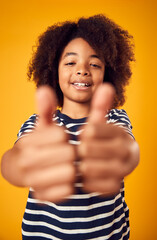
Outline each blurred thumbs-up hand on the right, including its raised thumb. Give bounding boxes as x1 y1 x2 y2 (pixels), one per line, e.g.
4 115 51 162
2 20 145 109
78 84 139 196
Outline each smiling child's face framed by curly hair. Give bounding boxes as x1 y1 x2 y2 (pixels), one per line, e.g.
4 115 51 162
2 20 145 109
58 38 105 107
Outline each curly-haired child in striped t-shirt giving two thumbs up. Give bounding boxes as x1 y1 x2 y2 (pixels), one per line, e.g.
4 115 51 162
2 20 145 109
2 15 139 240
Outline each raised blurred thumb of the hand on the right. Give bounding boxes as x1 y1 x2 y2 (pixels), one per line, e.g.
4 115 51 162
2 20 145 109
89 83 115 123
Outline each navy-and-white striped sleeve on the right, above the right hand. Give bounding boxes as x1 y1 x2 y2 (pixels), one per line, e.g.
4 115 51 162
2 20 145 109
106 109 135 139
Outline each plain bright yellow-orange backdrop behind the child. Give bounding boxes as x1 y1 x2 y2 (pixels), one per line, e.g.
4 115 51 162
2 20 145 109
0 0 157 240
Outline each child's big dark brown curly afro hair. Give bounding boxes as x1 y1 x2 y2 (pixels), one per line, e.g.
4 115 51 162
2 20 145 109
27 15 135 107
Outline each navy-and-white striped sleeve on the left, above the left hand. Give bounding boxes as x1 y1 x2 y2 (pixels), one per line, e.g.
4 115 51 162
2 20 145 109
17 114 38 141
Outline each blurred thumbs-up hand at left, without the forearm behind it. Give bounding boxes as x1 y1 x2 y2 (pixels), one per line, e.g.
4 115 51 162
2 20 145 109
15 87 76 202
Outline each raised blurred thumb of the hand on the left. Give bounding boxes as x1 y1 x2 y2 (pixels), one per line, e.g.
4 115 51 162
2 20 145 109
36 86 57 127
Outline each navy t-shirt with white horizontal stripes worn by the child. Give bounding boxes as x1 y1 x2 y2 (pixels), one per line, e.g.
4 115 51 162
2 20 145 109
18 109 133 240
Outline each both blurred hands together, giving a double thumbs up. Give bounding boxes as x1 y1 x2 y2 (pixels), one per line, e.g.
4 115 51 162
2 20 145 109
2 84 139 202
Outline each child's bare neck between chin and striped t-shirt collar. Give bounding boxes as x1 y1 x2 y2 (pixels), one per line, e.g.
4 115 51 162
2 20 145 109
61 102 90 119
